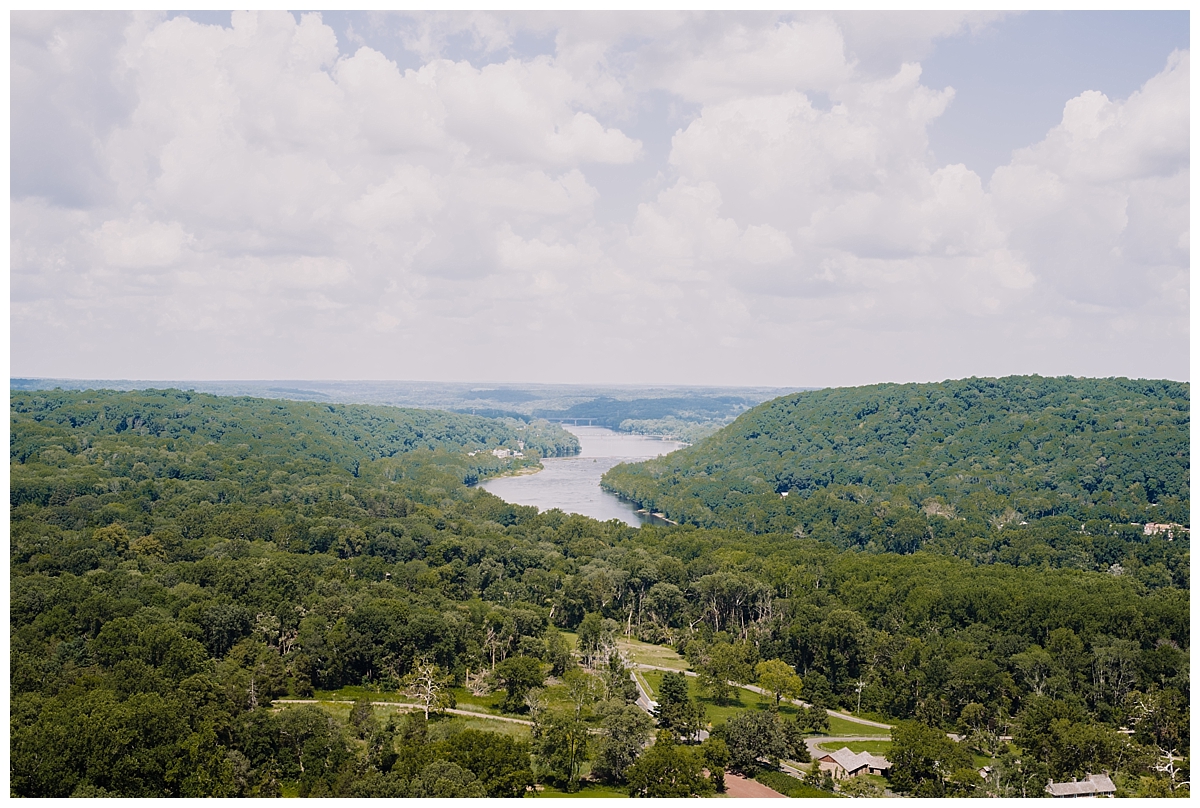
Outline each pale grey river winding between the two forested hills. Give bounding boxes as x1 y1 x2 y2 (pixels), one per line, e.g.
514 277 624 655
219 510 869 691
480 425 684 527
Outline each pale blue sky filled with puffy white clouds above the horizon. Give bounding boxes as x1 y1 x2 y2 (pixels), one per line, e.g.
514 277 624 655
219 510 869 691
10 12 1190 387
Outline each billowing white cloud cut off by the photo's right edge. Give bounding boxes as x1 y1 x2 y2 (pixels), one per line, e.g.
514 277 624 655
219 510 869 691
990 53 1189 312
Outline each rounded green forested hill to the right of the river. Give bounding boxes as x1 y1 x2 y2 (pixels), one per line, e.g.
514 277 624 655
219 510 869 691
605 376 1190 580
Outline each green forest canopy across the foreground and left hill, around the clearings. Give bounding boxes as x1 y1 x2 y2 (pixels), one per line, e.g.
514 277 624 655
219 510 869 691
10 391 1190 797
